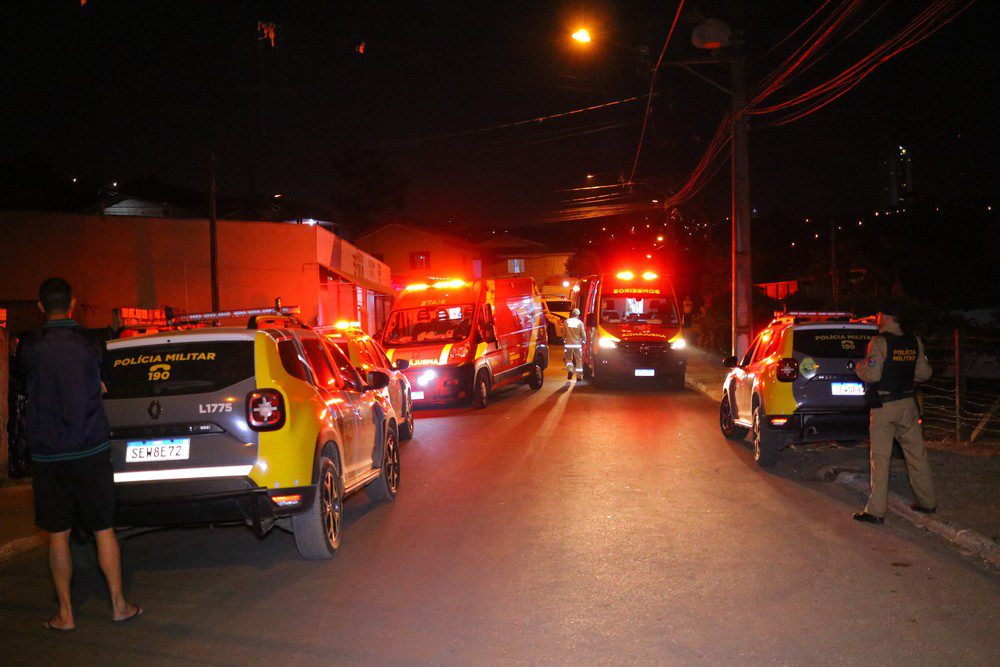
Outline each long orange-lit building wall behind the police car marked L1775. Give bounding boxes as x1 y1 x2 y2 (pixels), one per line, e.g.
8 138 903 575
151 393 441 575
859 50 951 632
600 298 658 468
0 211 370 330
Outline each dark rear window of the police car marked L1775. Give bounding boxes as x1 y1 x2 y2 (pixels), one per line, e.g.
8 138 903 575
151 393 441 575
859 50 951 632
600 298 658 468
106 340 254 398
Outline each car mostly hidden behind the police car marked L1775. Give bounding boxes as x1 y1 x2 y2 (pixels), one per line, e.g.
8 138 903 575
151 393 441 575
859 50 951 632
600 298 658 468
317 321 414 440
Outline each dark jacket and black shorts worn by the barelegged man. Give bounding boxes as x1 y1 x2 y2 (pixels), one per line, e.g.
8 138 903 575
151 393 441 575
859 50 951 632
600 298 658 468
16 319 114 533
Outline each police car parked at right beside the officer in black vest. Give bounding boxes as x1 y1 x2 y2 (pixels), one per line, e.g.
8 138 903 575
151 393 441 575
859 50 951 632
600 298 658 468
719 312 878 467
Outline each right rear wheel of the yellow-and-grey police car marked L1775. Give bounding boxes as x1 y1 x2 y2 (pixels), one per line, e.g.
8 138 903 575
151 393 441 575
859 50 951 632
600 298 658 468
292 456 344 560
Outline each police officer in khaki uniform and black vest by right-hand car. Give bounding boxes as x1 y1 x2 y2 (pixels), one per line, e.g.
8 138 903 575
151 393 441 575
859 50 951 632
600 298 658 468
854 304 937 524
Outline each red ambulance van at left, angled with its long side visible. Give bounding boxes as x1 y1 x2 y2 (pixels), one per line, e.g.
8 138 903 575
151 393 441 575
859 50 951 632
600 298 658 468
380 278 549 408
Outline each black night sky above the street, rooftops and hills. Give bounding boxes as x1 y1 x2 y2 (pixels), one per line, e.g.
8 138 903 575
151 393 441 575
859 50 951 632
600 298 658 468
0 0 1000 229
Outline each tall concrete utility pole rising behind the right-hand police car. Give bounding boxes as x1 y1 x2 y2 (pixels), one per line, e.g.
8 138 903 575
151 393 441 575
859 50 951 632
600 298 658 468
730 42 753 358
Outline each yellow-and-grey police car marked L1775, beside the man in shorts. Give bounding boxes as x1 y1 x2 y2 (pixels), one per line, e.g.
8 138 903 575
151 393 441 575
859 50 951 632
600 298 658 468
105 311 400 559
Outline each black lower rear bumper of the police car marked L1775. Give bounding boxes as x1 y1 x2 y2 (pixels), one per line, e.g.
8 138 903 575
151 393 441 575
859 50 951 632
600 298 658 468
115 477 316 534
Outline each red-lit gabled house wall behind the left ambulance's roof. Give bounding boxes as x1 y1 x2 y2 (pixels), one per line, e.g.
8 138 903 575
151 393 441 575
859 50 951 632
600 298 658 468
356 224 479 287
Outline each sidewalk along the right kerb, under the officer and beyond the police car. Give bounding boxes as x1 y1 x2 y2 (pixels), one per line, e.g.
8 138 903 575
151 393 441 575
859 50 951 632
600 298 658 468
687 348 1000 565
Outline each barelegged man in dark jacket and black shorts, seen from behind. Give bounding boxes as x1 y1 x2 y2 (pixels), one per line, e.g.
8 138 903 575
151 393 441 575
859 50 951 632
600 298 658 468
17 278 142 630
